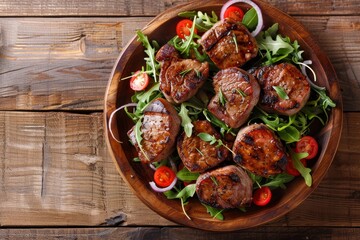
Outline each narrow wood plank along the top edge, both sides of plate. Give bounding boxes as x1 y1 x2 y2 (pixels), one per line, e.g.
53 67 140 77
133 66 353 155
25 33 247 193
0 0 360 17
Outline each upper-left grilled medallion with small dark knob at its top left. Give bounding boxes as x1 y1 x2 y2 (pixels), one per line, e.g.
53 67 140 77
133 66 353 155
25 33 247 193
156 44 209 103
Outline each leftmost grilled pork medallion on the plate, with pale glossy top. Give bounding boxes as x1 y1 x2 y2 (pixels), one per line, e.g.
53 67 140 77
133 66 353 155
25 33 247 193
128 98 181 163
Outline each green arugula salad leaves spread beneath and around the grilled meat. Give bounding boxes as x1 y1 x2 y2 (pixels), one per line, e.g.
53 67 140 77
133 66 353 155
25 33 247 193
119 5 335 220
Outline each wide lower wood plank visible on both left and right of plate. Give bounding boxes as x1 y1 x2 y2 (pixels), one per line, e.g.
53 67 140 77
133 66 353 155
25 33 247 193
0 111 360 227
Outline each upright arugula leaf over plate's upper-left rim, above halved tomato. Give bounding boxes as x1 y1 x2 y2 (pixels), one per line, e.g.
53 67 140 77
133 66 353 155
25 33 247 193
136 30 160 82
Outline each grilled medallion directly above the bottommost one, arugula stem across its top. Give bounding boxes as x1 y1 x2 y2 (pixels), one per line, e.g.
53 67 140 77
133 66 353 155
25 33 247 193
177 121 230 173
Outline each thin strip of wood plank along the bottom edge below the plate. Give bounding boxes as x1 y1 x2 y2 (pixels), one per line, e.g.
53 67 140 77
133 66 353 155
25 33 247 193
0 227 360 240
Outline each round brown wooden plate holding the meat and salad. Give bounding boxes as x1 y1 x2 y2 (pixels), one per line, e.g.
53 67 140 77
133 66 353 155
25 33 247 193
104 0 342 231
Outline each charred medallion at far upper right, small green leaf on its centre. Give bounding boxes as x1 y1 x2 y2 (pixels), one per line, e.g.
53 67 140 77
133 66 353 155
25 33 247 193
252 63 310 116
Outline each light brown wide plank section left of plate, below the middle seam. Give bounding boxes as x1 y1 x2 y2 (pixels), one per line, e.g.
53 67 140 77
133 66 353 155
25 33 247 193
0 112 172 226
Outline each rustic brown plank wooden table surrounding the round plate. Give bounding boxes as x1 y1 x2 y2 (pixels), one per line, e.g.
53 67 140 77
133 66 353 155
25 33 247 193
0 0 360 239
